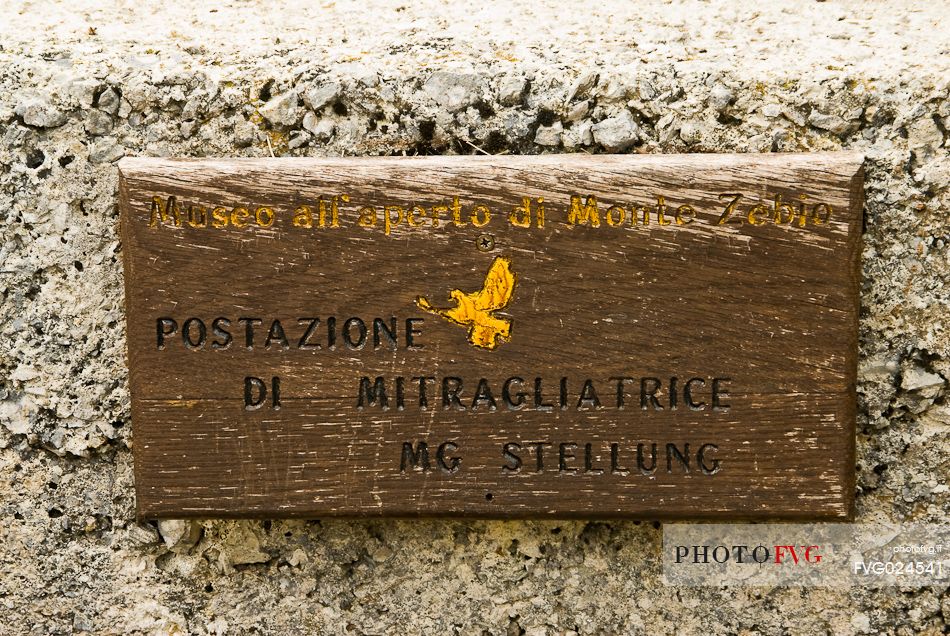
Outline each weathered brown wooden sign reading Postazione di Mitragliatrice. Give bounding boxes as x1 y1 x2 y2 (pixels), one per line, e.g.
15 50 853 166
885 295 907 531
120 154 862 519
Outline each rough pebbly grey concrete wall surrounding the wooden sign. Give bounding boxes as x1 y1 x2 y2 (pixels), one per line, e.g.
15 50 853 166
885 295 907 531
0 0 950 634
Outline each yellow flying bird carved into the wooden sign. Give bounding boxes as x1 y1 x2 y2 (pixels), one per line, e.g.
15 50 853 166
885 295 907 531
416 256 515 350
